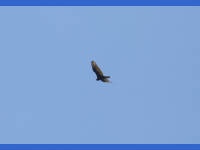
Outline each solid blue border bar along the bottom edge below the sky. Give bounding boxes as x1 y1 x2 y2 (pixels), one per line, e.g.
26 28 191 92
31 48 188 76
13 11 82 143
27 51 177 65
0 144 200 150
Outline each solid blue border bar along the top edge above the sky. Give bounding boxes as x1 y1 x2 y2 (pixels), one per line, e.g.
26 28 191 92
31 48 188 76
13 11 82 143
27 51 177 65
0 0 200 6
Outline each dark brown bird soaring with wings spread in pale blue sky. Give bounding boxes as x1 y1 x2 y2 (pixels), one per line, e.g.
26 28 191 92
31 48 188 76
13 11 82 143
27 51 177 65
91 61 110 82
